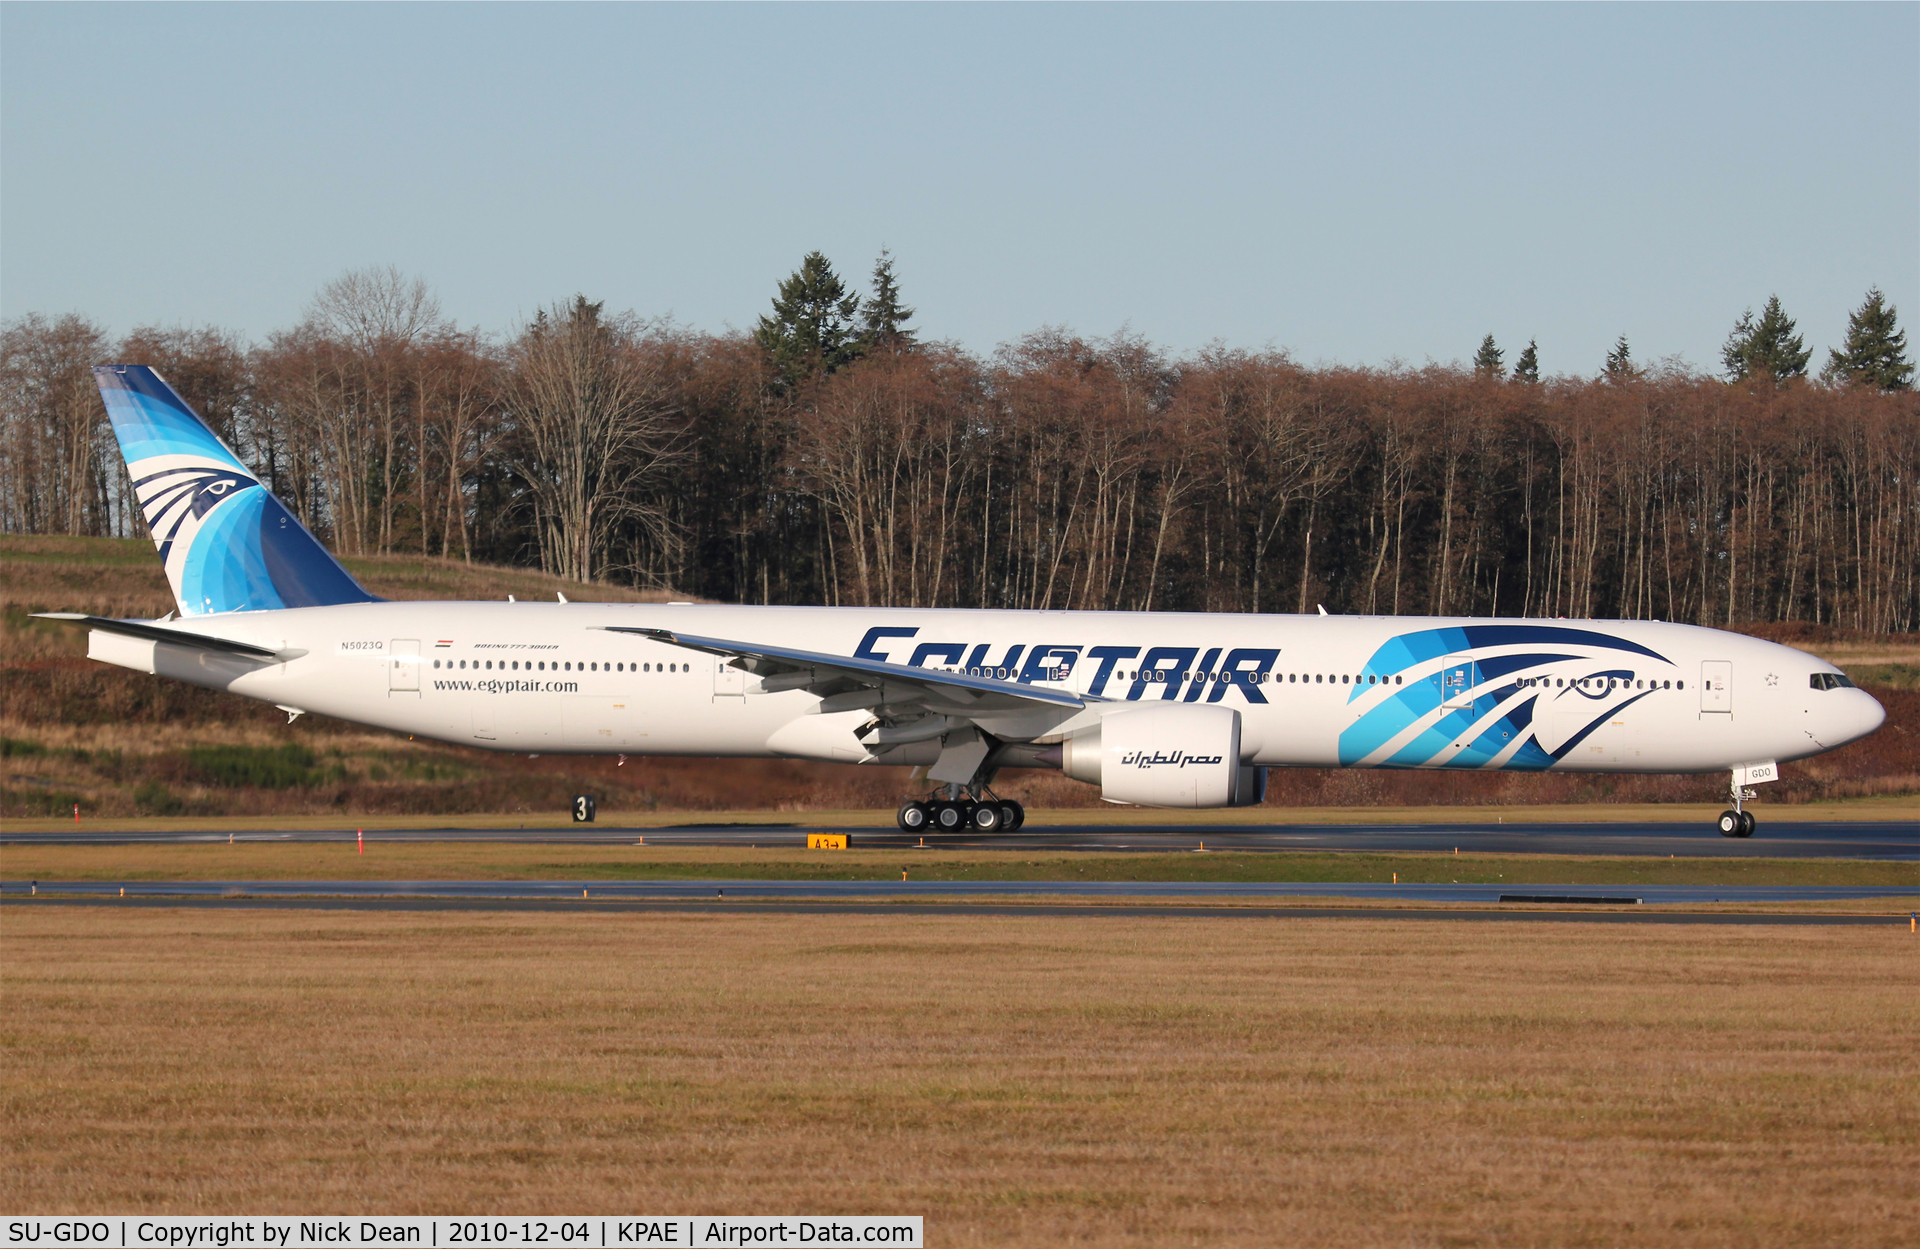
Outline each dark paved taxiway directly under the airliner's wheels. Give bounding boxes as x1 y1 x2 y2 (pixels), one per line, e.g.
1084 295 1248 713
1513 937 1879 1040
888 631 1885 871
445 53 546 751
0 815 1920 861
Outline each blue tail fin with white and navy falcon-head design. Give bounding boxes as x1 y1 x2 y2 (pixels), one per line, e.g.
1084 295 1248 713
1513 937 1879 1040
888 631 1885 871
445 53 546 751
94 365 378 616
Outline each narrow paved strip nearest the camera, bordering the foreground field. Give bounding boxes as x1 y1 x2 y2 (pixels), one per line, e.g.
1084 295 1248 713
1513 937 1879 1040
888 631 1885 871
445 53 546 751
0 879 1920 906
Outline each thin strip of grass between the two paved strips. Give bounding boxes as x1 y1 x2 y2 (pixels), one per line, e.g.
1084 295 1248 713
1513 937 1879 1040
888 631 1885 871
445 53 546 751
0 838 1920 894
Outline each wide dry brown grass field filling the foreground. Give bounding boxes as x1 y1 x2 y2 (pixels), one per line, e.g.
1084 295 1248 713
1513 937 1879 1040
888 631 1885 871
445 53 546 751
0 906 1920 1245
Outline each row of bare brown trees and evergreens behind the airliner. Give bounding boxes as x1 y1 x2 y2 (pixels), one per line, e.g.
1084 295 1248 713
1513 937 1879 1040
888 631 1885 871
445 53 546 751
0 264 1920 631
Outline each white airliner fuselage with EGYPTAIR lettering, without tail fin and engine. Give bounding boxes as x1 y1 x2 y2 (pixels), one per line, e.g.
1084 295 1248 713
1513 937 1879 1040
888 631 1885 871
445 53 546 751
92 602 1884 771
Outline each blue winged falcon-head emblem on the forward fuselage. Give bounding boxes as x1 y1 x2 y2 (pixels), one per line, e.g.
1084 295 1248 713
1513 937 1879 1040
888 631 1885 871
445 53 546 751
1340 624 1668 771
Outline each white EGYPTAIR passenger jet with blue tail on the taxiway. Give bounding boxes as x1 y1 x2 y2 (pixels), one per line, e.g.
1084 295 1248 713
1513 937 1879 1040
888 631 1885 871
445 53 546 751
44 365 1885 837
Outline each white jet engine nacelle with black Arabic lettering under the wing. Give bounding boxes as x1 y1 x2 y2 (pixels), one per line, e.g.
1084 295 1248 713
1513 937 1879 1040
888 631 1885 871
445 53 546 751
1060 702 1267 808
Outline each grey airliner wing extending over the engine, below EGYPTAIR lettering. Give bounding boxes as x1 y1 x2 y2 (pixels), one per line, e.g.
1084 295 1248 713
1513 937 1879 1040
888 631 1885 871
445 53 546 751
605 625 1087 716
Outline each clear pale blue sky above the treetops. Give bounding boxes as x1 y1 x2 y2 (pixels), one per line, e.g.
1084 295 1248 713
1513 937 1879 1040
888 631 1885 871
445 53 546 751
0 2 1920 372
